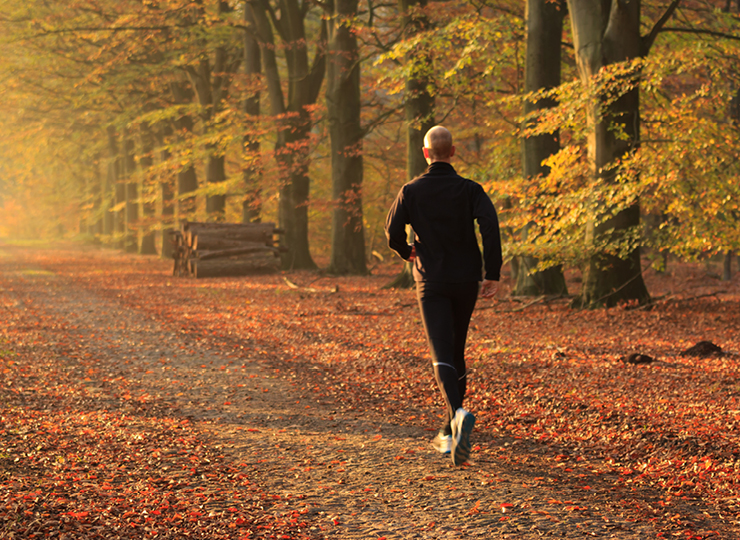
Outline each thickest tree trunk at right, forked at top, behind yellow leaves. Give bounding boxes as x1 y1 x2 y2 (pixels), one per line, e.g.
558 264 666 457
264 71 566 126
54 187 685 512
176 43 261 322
568 0 650 307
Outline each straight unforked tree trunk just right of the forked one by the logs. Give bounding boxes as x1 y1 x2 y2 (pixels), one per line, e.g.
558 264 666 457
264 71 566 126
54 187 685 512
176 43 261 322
326 0 367 274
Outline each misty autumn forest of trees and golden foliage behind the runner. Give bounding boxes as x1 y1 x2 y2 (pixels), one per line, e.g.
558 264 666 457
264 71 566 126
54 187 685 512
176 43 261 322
0 0 740 306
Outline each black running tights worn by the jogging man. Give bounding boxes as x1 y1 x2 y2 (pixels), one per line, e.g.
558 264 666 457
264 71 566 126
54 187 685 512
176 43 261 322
416 281 478 434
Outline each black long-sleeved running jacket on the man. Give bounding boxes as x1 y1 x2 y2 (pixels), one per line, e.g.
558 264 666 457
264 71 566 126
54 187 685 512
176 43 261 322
385 161 502 283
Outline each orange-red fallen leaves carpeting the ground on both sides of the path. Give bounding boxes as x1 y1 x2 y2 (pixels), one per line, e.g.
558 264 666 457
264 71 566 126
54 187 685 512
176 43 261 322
0 247 740 538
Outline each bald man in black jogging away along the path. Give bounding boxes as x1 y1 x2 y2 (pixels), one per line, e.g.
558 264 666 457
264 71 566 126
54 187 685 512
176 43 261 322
385 126 502 465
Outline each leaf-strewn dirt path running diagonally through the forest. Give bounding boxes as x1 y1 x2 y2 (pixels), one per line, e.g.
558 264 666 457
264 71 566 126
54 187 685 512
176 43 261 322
0 249 729 540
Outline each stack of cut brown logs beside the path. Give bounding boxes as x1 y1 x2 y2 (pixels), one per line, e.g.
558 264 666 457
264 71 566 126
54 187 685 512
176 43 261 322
170 221 281 278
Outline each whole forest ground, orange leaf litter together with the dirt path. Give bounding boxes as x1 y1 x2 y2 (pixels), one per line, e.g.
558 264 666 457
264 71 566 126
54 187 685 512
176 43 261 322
0 244 740 540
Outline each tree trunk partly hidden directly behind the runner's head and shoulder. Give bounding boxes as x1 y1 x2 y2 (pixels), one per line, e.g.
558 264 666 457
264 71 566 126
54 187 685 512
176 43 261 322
385 0 435 289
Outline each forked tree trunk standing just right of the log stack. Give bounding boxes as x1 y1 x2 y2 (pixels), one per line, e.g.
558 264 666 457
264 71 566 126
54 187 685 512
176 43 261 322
248 0 326 269
